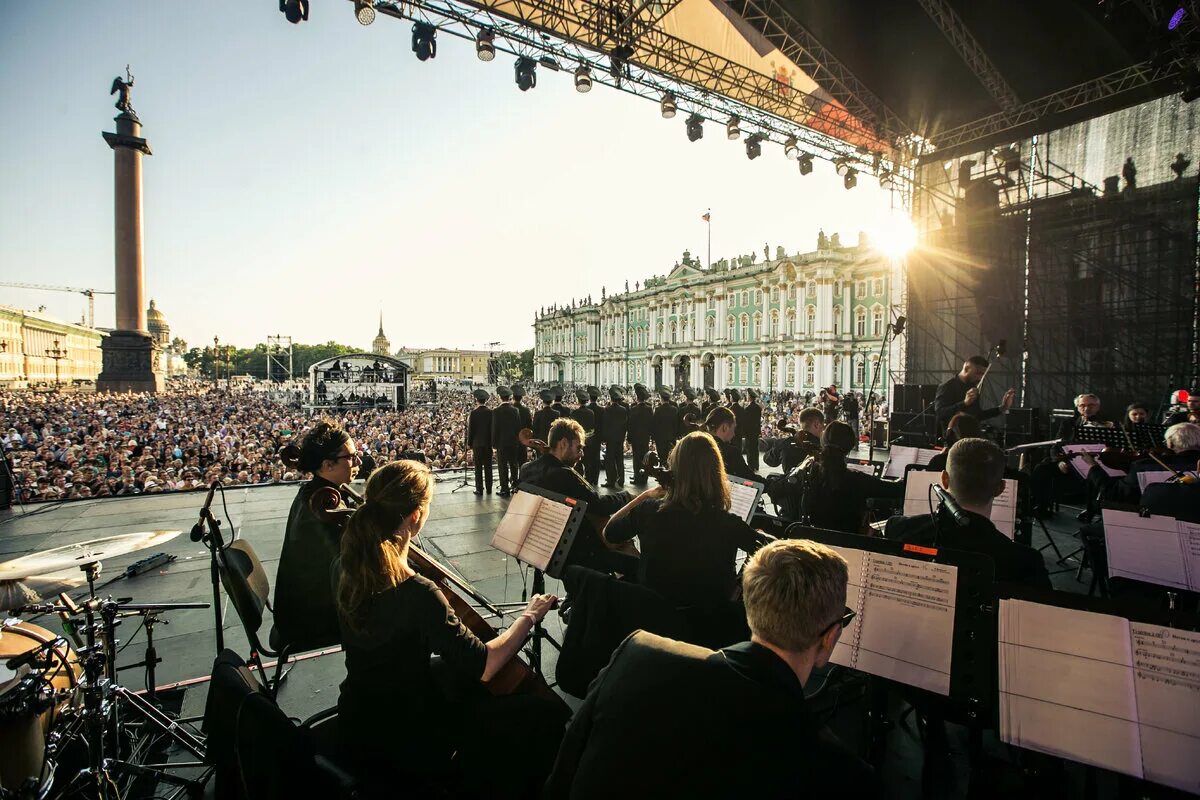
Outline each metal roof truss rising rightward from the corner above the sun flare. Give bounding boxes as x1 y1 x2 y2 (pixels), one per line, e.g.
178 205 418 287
918 59 1186 163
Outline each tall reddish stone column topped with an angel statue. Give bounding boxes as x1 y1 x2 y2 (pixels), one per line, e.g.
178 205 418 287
96 67 163 392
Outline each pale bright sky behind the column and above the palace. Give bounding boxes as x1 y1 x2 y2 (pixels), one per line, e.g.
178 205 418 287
0 0 899 349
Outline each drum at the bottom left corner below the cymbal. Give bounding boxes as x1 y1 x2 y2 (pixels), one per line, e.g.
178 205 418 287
0 620 80 796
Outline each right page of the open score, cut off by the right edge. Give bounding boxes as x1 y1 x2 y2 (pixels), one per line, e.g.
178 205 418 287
1129 622 1200 793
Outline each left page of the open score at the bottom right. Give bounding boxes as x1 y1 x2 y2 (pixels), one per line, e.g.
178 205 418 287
1000 600 1142 777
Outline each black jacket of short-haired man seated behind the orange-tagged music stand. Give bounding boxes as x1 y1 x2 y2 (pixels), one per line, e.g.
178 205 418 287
884 510 1051 589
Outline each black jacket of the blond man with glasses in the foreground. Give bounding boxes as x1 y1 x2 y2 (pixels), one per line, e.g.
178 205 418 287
544 631 874 800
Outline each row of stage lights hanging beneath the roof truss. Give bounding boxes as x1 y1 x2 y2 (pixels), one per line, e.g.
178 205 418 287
280 0 878 190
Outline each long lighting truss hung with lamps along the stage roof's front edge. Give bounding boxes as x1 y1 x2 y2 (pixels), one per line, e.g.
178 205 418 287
350 0 912 193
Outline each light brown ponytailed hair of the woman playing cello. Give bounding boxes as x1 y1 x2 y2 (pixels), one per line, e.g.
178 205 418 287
337 461 433 633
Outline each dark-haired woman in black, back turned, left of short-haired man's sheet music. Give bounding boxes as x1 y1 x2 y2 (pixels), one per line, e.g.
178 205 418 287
802 422 904 534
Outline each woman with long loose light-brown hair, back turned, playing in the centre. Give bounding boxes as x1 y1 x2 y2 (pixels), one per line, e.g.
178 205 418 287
604 432 757 614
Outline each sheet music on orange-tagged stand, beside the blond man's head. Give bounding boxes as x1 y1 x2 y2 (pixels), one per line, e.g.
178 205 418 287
830 547 959 694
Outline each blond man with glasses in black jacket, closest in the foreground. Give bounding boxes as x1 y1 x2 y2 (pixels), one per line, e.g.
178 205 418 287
544 540 875 800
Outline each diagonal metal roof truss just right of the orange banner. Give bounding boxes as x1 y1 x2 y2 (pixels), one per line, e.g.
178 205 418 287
727 0 912 139
